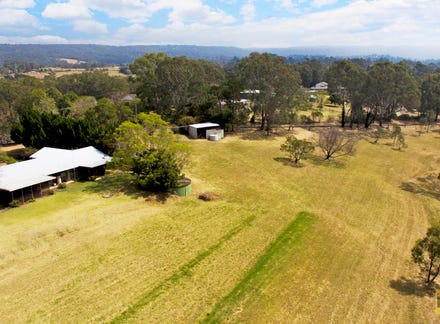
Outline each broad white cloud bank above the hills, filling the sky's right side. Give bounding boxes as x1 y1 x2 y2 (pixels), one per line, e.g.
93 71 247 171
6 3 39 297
105 0 440 55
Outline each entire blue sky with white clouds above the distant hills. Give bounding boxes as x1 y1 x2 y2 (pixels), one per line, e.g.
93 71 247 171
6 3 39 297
0 0 440 58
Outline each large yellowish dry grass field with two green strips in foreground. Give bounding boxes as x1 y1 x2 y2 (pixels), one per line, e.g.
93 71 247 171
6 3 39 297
0 124 440 323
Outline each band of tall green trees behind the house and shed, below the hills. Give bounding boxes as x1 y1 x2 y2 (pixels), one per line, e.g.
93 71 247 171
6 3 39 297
0 53 440 152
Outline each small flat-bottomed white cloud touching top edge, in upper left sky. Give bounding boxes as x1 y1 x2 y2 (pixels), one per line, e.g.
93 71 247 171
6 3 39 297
41 0 91 20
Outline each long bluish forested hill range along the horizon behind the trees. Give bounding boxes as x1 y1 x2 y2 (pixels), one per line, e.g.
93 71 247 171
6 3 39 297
0 44 432 66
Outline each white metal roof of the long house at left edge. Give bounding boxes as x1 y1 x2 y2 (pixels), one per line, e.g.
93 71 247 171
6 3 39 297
0 146 112 191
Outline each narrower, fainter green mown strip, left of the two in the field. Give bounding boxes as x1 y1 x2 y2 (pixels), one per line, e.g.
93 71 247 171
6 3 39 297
110 215 256 323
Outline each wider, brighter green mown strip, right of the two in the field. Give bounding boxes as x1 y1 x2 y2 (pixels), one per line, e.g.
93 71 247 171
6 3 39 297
202 212 317 323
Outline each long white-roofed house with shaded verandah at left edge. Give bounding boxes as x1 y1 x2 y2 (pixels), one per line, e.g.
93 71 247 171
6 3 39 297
0 146 111 204
